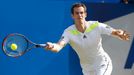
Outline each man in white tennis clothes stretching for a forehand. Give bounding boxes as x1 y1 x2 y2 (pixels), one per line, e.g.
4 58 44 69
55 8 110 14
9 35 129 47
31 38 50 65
45 3 130 75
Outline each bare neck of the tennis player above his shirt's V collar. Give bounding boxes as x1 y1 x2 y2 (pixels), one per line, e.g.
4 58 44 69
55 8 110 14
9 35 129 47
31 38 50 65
75 21 87 33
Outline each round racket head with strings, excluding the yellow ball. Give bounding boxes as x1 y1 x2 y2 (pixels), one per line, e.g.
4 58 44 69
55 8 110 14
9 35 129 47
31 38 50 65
2 33 29 57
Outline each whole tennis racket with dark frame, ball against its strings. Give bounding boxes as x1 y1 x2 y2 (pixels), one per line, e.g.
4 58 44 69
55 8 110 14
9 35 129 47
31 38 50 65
2 33 46 57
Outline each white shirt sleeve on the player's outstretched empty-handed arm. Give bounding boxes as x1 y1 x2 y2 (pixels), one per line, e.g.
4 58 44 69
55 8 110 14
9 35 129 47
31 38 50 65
99 23 114 35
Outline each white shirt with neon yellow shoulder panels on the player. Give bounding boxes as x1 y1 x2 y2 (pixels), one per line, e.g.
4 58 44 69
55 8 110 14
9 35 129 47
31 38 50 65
61 21 113 64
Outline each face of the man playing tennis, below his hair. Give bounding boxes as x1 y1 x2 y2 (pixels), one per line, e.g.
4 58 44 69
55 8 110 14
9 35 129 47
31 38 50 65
72 7 87 22
